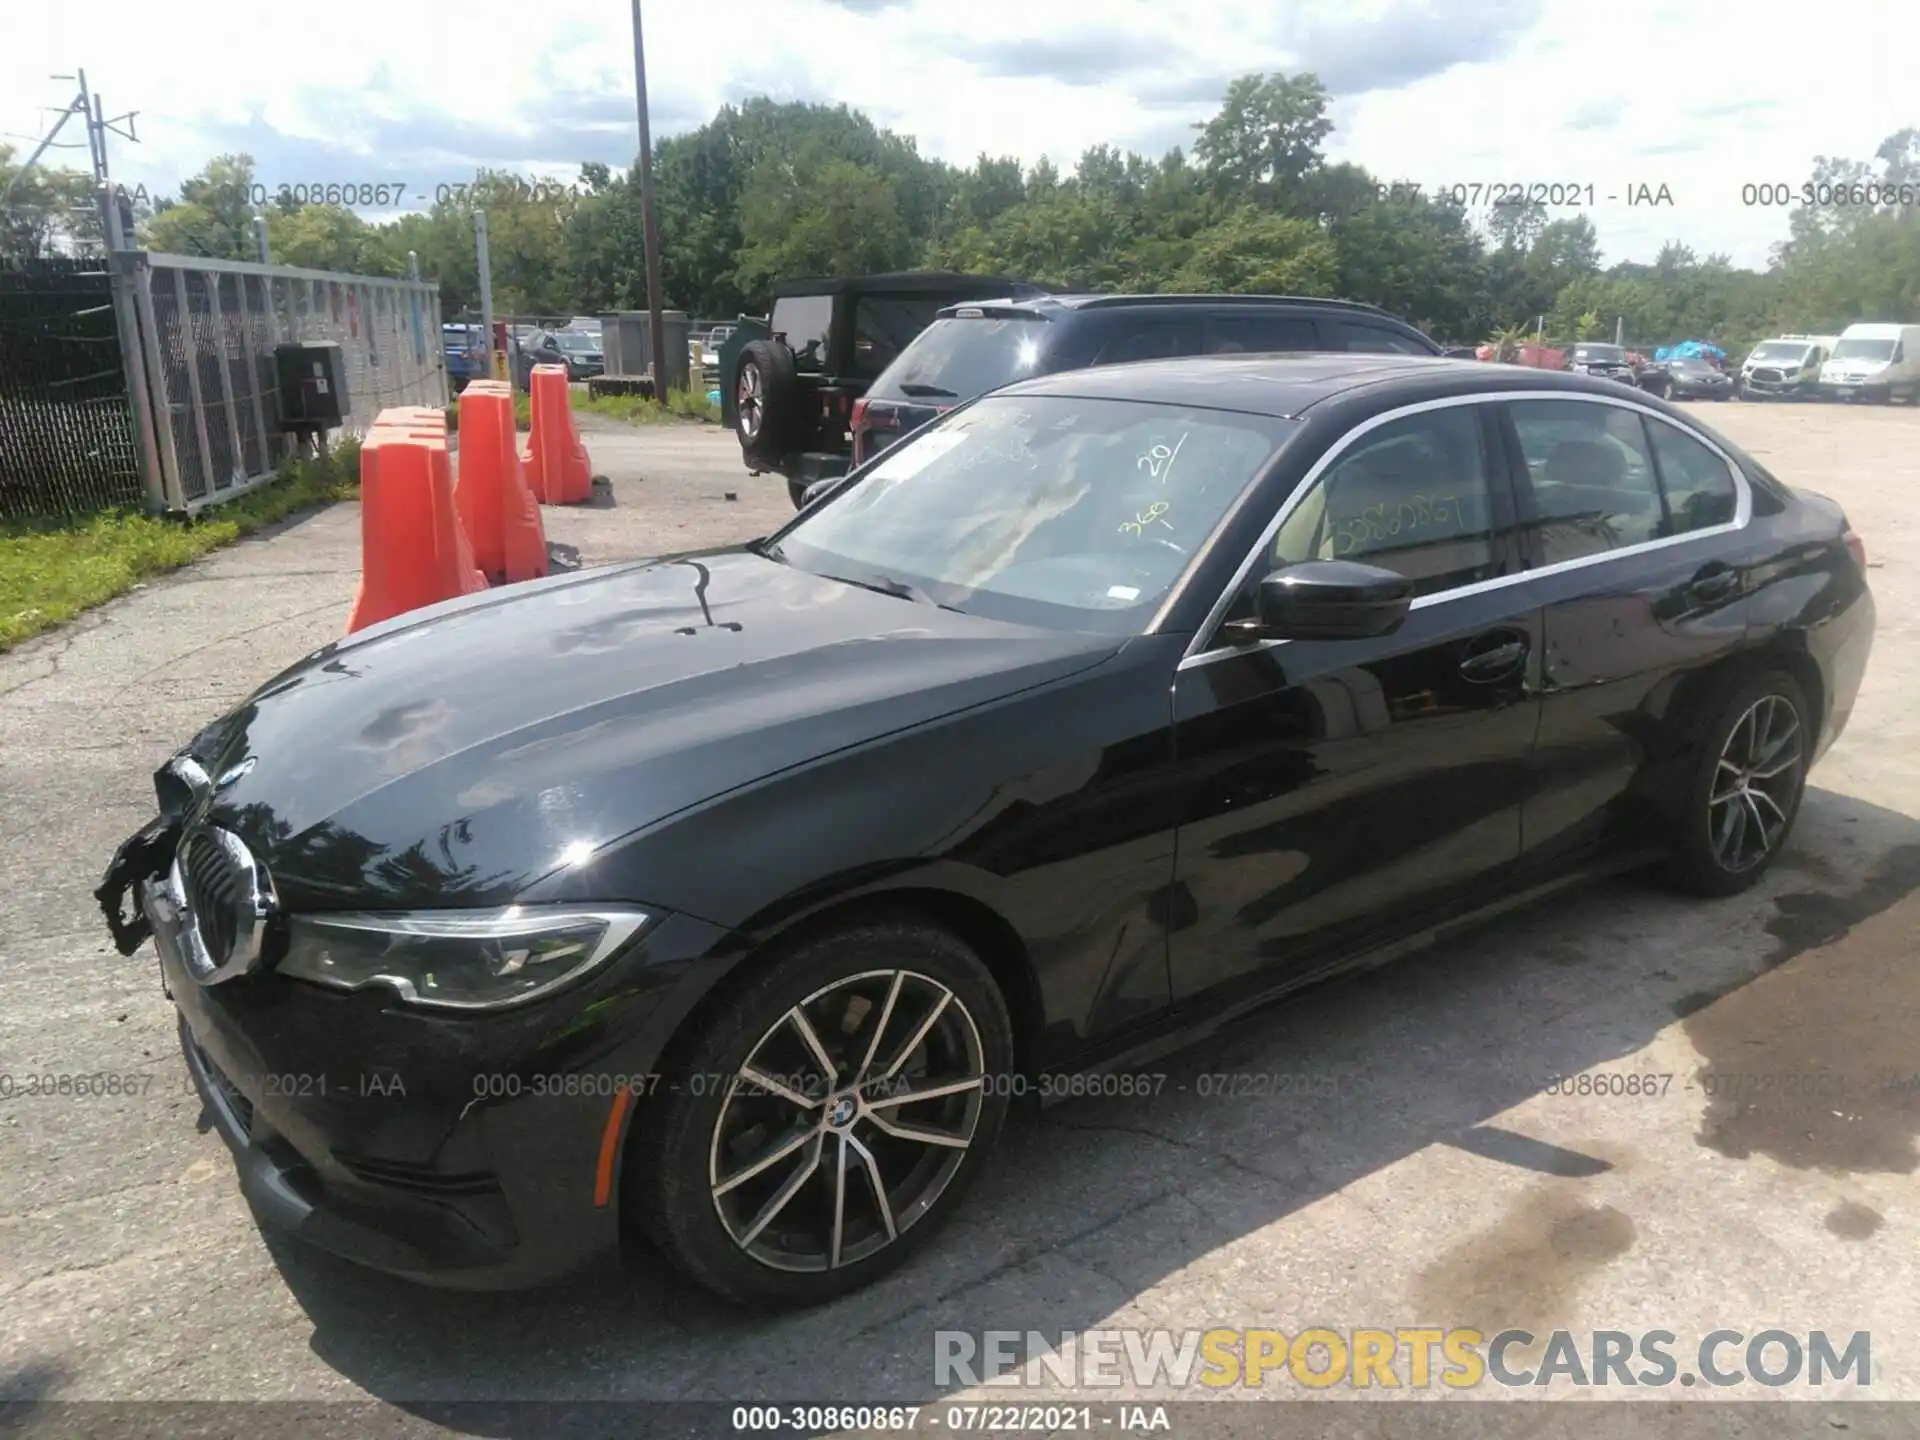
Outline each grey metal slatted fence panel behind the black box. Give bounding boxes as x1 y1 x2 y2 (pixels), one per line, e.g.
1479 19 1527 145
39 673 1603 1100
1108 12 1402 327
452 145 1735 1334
139 252 447 511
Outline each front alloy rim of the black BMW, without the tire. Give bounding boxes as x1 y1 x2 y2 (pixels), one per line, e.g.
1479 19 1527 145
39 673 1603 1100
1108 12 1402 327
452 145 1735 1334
708 970 987 1271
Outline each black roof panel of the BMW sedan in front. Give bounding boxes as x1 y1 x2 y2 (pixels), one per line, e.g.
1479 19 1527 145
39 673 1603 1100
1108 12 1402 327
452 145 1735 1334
993 351 1651 419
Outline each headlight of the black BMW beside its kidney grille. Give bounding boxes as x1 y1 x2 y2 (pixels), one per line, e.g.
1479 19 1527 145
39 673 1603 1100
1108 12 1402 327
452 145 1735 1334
276 904 649 1010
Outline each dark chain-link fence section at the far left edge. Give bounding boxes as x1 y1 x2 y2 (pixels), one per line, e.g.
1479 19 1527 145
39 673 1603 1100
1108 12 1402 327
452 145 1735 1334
0 255 144 516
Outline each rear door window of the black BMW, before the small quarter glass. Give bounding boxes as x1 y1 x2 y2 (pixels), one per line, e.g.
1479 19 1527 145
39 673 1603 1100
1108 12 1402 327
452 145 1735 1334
1507 399 1667 564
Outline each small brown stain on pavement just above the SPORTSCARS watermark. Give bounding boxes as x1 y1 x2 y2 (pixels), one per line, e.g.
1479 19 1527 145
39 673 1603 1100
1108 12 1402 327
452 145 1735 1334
1409 1187 1634 1357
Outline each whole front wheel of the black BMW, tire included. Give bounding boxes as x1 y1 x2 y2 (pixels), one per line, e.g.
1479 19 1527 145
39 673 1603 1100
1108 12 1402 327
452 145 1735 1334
626 918 1014 1308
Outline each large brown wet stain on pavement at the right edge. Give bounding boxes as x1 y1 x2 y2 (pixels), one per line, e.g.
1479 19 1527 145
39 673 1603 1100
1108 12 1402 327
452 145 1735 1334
1684 845 1920 1175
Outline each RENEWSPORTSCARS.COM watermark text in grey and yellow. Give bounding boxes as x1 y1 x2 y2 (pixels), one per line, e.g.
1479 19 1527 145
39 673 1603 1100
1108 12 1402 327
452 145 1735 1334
933 1325 1872 1394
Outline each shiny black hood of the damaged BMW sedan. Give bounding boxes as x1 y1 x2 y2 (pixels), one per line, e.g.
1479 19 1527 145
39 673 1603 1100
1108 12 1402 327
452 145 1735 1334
188 551 1121 908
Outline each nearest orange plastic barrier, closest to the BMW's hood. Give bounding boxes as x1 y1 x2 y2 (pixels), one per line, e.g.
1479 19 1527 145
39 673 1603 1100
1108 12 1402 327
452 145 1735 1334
348 407 486 636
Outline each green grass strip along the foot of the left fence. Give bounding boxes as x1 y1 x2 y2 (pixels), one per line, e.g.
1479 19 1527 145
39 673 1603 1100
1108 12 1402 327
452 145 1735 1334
0 440 359 651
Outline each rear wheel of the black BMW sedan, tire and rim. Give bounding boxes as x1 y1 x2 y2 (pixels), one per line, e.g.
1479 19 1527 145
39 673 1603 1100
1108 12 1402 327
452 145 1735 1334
1667 670 1812 897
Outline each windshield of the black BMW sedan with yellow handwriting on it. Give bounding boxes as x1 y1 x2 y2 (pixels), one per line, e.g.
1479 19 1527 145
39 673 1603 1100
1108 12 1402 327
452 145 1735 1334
768 396 1300 636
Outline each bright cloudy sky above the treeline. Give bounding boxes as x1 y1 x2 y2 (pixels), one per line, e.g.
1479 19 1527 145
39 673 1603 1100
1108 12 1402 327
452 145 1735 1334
0 0 1920 265
